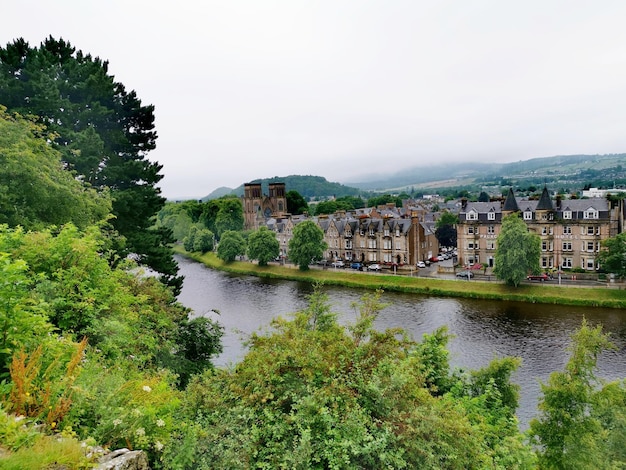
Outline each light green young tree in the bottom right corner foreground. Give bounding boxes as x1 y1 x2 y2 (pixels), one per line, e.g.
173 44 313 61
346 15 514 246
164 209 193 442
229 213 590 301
530 320 626 469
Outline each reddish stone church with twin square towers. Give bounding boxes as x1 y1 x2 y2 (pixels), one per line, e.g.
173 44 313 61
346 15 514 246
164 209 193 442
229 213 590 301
242 183 287 230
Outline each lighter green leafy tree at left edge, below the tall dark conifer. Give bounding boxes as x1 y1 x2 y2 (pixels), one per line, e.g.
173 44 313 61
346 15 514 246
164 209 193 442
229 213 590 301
0 106 111 229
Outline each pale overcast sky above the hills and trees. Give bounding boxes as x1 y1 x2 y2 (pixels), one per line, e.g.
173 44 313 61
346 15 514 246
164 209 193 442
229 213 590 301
0 0 626 199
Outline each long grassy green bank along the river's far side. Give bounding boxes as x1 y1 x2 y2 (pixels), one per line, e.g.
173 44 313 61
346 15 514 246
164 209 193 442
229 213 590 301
174 246 626 308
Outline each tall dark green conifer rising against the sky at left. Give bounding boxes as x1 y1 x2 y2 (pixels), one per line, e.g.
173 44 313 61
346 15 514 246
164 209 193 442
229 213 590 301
0 37 182 291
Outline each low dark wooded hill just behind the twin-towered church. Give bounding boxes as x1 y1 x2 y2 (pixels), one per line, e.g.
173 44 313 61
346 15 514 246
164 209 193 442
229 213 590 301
202 175 361 201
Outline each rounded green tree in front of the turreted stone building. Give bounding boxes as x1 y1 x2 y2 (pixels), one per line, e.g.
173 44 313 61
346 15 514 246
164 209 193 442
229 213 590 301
493 214 541 287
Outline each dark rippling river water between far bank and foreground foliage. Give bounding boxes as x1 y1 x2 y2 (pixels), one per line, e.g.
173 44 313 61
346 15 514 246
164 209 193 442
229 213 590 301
177 257 626 429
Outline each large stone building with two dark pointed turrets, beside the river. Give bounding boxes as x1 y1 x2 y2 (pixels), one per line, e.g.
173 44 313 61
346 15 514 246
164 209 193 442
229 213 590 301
457 188 619 271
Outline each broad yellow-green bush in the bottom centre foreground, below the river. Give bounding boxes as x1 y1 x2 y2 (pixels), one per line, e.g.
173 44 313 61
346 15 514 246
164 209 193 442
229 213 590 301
164 290 533 469
